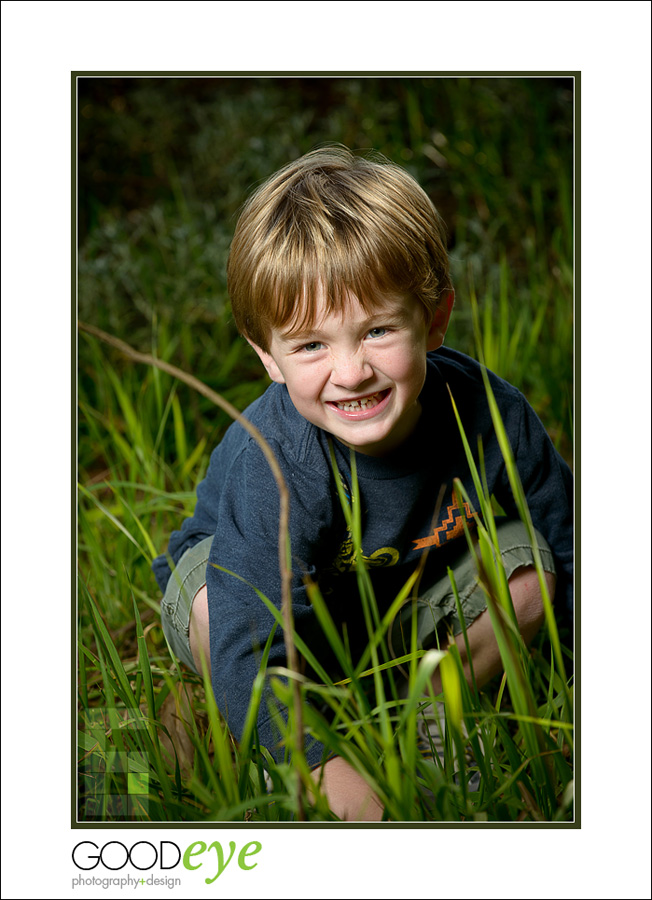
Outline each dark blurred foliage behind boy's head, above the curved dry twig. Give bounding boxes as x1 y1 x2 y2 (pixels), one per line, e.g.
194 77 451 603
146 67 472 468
78 77 573 466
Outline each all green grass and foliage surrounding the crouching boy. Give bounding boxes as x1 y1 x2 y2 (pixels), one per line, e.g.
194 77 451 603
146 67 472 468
77 78 574 822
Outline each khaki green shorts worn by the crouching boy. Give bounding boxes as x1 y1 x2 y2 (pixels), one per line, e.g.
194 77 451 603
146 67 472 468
161 520 555 672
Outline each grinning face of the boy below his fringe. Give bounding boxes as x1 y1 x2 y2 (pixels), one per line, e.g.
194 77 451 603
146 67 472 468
254 291 453 456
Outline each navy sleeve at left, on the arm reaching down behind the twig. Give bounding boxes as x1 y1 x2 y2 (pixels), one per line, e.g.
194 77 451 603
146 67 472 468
207 441 333 765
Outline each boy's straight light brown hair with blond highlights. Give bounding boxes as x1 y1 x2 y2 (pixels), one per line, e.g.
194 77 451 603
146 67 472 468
227 146 452 352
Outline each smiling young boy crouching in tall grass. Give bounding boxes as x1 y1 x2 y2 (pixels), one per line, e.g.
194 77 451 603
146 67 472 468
154 147 572 820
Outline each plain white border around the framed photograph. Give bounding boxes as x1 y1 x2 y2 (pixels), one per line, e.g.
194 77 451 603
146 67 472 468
2 0 650 898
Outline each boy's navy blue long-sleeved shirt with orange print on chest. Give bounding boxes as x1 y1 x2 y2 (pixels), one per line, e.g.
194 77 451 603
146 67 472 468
153 347 573 765
